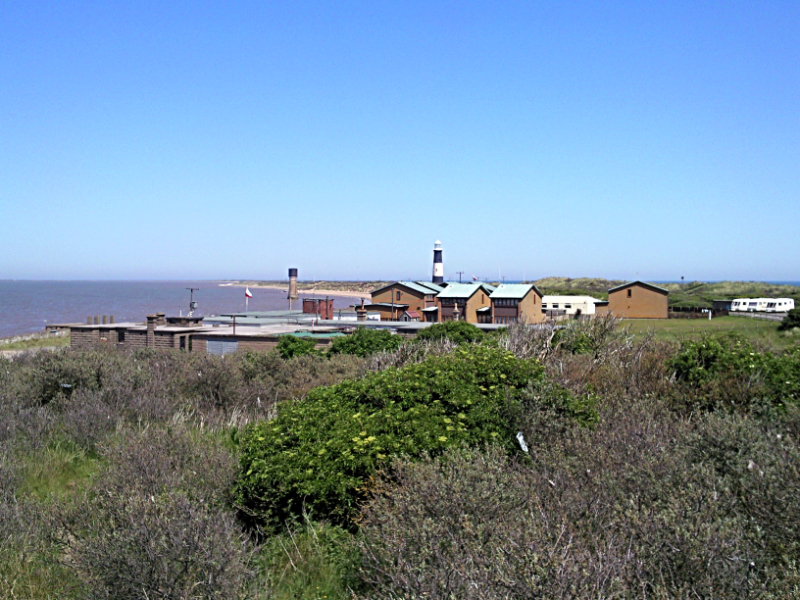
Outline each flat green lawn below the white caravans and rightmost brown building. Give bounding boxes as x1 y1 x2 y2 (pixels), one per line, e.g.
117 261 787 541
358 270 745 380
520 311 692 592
622 316 800 350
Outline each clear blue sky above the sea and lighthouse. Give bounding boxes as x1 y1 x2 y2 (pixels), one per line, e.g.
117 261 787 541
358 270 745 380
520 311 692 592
0 0 800 280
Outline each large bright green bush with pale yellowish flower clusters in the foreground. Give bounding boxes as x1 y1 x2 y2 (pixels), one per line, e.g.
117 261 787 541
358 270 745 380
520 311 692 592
235 345 543 527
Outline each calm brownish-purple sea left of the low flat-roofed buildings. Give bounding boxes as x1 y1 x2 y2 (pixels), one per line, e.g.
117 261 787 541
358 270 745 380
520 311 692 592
0 281 358 337
